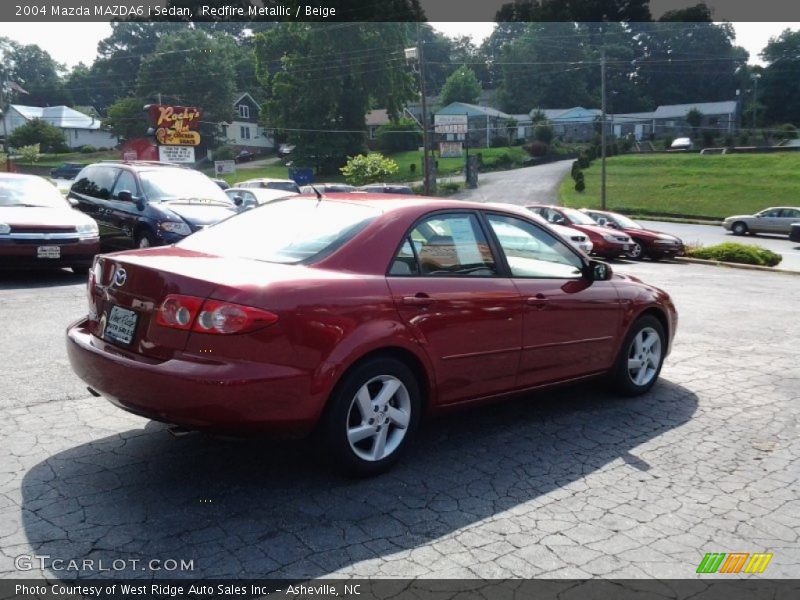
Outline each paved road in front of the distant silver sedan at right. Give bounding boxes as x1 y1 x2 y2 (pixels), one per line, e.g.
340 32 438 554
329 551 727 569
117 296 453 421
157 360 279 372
640 221 800 271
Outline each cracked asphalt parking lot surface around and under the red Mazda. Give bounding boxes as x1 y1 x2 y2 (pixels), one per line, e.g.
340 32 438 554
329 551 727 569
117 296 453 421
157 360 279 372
0 262 800 578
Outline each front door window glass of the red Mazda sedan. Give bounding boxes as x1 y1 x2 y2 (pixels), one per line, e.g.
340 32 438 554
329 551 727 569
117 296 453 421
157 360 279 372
488 215 583 279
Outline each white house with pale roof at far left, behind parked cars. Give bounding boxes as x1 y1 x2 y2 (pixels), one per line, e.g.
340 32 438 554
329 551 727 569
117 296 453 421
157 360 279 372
3 104 119 149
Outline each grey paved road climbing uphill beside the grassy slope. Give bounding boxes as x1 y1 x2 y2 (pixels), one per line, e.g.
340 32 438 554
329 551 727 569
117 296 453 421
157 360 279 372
453 160 573 205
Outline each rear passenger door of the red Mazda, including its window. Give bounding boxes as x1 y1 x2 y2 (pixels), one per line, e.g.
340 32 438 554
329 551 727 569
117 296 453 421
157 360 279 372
387 212 522 404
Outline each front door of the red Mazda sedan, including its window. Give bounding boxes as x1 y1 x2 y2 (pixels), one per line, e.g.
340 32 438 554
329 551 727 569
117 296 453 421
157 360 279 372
478 214 620 387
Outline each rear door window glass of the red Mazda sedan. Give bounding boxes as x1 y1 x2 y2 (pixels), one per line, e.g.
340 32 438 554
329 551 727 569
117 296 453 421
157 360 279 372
389 213 497 277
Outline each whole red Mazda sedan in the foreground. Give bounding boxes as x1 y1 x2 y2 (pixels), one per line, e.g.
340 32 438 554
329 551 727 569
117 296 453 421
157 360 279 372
67 194 677 475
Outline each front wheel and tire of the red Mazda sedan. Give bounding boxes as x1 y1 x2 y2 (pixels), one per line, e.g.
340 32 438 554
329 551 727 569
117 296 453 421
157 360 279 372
611 315 667 396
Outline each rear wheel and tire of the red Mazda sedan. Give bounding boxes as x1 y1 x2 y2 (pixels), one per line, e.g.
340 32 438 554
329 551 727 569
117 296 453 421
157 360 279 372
321 357 422 477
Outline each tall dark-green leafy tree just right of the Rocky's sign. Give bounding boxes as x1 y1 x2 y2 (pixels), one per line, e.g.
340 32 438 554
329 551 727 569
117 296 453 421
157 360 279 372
255 22 414 172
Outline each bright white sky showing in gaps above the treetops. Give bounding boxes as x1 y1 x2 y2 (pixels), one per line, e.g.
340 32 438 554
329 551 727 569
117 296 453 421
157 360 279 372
0 23 800 67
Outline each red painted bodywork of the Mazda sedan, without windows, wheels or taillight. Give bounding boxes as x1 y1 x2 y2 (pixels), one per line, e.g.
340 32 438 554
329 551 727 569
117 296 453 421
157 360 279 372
67 194 675 435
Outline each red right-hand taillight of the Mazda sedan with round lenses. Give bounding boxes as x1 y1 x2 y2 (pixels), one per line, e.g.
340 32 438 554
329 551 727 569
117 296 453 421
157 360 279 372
156 294 278 334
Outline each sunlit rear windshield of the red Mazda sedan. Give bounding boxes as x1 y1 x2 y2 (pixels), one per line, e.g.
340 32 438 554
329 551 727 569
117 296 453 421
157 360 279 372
178 198 381 263
